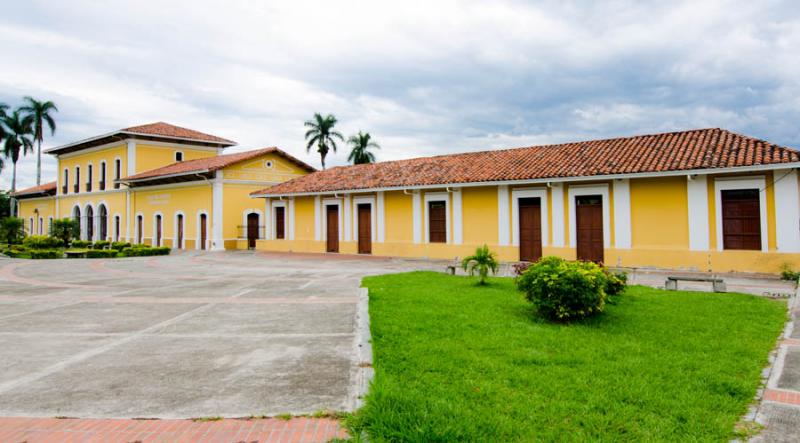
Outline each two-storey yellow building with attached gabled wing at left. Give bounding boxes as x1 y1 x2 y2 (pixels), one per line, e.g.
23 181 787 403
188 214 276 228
15 122 314 250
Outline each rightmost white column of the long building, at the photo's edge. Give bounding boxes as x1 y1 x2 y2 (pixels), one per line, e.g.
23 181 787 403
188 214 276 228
772 169 800 252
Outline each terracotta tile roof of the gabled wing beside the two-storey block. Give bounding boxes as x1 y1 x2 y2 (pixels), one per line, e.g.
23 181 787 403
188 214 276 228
120 148 316 182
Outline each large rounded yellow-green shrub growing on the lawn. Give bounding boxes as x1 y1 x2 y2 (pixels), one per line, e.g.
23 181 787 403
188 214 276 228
517 257 609 322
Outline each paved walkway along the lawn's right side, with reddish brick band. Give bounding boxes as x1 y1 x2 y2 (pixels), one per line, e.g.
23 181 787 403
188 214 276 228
751 282 800 443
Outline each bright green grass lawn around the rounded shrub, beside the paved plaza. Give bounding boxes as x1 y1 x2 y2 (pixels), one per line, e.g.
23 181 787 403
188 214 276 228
350 272 786 441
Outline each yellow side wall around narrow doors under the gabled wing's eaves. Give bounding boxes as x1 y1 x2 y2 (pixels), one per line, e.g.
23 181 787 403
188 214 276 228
131 183 213 249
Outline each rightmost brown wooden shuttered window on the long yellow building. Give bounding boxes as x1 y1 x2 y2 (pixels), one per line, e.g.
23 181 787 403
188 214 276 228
722 189 761 251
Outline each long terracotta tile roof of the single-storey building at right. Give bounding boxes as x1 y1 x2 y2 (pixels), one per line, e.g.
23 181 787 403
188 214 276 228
251 128 800 195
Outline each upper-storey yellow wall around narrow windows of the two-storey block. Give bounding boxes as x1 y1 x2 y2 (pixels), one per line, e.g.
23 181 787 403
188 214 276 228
56 144 128 195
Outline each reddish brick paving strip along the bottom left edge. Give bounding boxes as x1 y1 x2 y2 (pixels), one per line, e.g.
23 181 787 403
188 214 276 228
0 418 347 443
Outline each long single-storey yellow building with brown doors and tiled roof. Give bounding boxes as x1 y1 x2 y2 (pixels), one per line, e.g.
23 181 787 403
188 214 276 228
252 129 800 272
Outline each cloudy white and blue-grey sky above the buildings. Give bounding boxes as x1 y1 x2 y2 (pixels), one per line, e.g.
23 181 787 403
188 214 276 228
0 0 800 188
